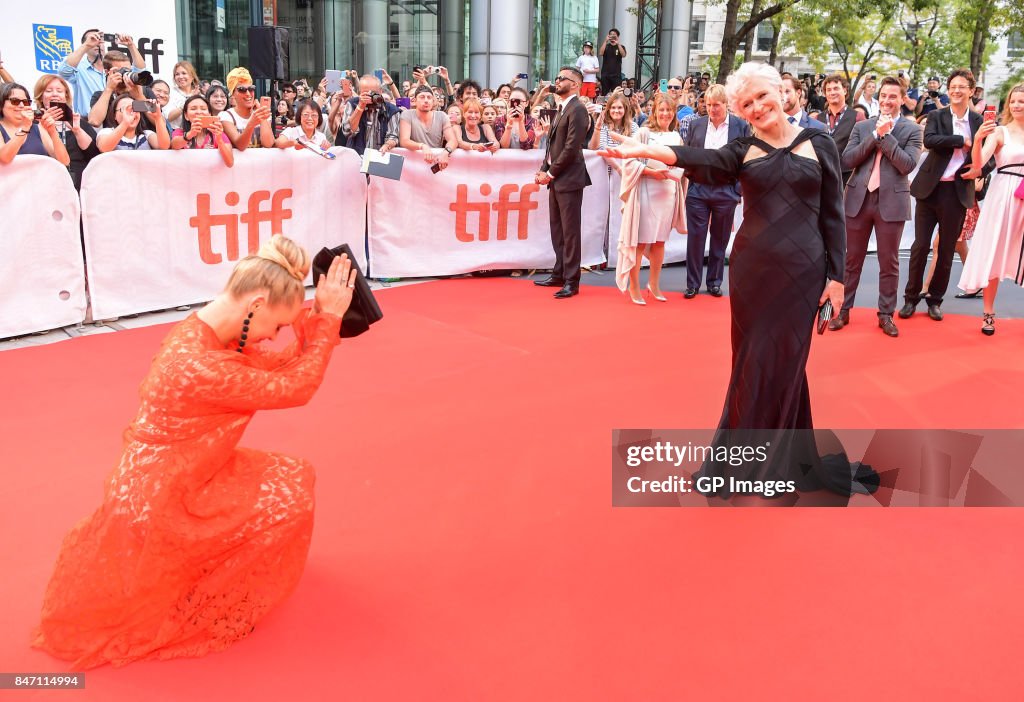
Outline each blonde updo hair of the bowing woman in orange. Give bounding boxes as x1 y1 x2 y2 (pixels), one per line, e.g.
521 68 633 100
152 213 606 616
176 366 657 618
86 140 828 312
225 234 309 305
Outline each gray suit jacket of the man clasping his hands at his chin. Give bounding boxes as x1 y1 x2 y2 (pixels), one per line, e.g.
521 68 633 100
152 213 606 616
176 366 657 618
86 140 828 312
841 117 922 222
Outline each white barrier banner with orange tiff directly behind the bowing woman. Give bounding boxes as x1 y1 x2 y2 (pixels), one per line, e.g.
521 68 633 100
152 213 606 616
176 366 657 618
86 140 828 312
82 148 367 319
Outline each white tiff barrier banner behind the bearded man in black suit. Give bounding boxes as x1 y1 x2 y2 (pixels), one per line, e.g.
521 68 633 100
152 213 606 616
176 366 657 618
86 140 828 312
368 149 608 277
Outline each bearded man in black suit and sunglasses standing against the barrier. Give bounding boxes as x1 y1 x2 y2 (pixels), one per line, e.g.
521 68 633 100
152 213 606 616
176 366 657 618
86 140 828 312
534 65 590 299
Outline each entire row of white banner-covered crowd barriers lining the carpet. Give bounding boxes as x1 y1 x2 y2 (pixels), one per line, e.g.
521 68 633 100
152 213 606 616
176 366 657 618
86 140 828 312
0 148 913 338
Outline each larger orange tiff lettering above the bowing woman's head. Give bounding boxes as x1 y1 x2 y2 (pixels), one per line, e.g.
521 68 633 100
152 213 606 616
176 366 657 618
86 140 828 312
188 188 292 265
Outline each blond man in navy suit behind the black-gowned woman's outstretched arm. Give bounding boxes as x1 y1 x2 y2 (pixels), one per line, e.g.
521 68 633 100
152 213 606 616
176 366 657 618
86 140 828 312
683 85 751 300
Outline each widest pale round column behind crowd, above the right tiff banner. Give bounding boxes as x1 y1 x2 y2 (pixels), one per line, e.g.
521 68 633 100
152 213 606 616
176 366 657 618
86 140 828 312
469 0 532 88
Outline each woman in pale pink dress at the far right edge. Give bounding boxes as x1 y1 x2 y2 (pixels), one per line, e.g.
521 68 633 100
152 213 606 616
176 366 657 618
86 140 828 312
959 83 1024 337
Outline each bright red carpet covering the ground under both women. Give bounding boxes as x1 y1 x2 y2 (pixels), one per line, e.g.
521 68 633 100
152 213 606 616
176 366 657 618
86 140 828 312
0 279 1024 702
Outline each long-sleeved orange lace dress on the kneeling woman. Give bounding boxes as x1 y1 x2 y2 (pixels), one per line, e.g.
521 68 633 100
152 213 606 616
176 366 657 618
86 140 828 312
33 310 341 669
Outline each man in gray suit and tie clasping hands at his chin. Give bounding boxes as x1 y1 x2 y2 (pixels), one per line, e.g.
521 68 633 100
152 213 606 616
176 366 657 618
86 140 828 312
828 76 922 337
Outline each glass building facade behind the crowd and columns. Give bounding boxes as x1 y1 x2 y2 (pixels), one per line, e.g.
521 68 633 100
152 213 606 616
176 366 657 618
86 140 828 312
175 0 599 87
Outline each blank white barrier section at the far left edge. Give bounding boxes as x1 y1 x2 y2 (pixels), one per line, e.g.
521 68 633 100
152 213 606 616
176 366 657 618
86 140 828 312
0 156 86 338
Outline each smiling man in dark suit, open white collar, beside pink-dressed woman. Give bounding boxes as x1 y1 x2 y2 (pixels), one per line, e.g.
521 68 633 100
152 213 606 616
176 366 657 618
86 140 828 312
899 69 994 321
